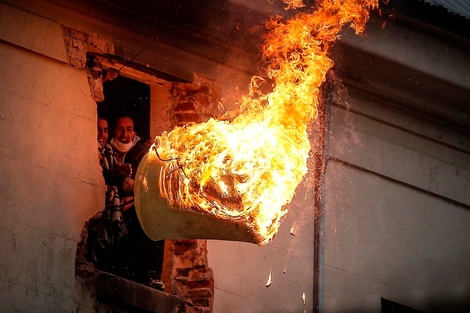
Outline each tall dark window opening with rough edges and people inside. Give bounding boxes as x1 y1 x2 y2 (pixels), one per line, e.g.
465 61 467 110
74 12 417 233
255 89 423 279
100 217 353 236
88 76 164 290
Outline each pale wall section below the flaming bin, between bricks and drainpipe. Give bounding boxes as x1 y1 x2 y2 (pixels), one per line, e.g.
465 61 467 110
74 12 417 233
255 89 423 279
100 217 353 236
207 172 314 313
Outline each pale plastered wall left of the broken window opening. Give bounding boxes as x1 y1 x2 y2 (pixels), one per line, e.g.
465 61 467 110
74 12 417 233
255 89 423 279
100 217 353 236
0 4 104 312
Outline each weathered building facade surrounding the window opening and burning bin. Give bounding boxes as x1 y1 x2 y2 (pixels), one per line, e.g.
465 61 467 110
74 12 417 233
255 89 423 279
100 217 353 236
0 0 470 313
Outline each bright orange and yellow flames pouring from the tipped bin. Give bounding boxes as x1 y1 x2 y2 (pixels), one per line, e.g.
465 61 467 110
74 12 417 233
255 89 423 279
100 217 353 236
136 0 378 245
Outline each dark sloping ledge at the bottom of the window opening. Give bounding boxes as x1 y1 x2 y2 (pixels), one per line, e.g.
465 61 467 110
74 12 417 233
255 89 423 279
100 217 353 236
95 272 185 313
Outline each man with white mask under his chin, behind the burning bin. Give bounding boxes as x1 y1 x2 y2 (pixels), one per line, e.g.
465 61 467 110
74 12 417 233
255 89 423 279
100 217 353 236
107 115 164 289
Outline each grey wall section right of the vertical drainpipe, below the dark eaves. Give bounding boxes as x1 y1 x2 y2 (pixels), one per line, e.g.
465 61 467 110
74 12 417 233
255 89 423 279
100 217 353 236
324 91 470 312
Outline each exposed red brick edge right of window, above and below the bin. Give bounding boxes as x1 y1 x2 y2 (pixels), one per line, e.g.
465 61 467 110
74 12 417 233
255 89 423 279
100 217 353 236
163 75 220 313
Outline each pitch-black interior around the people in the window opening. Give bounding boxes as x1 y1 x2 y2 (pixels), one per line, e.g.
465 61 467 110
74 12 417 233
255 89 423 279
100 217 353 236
92 76 164 290
